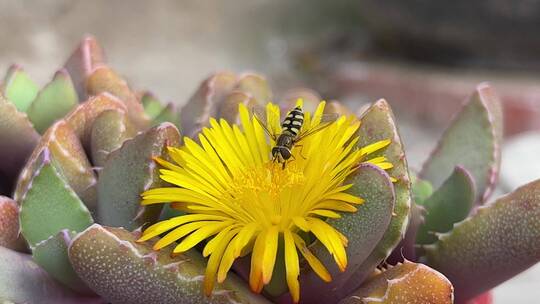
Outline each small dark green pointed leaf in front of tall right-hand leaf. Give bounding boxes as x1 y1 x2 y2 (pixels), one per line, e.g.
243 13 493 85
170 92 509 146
416 166 476 244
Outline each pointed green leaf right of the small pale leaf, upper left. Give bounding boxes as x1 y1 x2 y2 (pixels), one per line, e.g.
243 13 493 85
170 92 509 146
28 70 79 133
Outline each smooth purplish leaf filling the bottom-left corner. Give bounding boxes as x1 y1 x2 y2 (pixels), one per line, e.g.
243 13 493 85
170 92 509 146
0 247 104 304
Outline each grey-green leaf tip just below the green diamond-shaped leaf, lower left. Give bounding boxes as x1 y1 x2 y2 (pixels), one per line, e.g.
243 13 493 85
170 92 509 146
32 230 95 295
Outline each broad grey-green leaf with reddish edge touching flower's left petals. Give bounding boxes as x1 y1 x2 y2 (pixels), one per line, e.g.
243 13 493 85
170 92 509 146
97 123 180 230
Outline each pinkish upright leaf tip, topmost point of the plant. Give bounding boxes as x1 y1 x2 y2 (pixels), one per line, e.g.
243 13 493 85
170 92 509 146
64 36 105 101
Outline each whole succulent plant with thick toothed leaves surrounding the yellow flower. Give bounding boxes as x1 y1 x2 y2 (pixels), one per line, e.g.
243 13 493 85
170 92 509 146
0 37 540 303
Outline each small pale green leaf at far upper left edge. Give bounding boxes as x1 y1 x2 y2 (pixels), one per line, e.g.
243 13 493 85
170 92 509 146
3 65 39 113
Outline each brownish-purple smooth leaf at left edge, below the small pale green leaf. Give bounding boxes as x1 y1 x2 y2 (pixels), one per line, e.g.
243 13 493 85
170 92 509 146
0 94 39 194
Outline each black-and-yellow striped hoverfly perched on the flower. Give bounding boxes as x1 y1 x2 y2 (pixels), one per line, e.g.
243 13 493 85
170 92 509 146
253 106 339 169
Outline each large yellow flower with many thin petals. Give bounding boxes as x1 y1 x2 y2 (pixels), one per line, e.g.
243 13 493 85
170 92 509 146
139 101 392 302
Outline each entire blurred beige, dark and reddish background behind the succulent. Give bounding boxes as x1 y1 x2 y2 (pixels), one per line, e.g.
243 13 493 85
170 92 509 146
0 0 540 303
